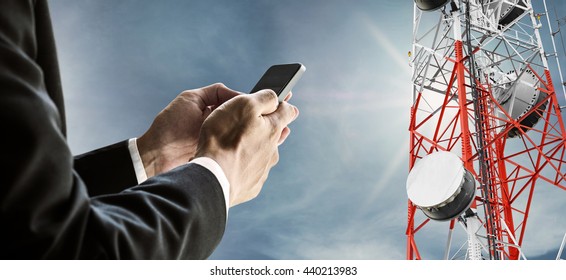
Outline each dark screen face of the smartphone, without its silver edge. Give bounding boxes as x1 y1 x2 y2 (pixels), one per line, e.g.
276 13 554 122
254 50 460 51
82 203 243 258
251 64 301 96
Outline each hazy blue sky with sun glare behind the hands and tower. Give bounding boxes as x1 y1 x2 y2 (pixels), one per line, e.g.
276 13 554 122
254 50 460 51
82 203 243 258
50 0 566 259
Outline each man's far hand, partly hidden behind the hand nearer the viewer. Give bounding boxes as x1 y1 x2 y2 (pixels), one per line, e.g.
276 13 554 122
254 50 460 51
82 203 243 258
141 84 240 178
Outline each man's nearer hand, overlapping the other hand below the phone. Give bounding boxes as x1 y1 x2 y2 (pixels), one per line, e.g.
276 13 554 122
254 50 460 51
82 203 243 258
196 90 299 206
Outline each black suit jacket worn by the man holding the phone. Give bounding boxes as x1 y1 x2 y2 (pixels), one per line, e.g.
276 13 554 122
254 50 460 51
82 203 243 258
0 0 226 259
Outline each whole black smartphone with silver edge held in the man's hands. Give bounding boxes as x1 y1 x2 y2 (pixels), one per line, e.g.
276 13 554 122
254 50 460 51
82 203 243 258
250 63 306 102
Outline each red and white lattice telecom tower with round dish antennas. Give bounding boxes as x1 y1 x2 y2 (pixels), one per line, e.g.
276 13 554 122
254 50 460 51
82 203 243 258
406 0 566 259
